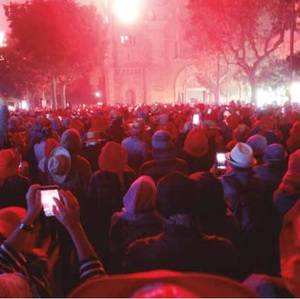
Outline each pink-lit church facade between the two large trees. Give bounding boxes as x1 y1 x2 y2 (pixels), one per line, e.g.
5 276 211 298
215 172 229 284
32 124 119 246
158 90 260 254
105 0 214 104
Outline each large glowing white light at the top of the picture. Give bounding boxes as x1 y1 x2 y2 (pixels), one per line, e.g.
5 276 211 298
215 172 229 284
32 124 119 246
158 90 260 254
112 0 141 24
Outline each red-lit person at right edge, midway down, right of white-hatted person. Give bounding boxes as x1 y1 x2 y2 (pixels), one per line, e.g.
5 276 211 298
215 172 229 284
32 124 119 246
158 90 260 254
273 149 300 217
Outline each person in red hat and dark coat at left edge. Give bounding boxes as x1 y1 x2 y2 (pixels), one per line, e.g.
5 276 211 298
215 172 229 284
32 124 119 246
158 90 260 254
0 149 30 208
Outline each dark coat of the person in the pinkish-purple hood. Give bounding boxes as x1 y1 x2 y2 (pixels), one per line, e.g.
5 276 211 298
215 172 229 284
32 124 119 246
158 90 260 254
110 212 163 272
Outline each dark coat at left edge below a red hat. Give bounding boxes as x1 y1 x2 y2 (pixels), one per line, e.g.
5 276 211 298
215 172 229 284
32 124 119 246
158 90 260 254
0 175 30 209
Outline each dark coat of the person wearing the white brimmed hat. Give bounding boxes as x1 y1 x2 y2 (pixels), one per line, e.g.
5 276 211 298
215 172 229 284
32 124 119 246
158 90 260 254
221 169 279 274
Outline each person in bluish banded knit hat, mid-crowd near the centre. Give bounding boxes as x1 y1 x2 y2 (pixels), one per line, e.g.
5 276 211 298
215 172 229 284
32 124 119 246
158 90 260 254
140 130 188 182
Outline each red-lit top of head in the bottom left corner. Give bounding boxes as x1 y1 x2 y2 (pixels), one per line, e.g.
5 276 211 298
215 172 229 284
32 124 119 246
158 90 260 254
0 273 34 298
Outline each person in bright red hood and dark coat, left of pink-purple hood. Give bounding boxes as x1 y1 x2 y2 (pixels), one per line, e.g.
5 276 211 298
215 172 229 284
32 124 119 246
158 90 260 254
83 141 135 263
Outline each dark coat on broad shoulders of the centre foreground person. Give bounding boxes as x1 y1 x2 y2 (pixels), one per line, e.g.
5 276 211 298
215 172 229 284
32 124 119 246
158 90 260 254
124 225 241 277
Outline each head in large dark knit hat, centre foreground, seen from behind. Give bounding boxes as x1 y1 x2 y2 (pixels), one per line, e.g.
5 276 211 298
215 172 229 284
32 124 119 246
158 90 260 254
157 172 196 218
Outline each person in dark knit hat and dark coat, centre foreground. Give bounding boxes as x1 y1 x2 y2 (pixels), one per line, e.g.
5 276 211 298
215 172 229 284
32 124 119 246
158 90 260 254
123 172 239 278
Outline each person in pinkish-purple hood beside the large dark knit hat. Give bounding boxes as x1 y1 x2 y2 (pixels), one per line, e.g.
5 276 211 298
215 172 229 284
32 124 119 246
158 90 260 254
110 176 162 271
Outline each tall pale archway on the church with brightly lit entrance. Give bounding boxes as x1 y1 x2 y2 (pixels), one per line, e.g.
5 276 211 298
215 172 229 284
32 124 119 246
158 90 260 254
175 65 212 103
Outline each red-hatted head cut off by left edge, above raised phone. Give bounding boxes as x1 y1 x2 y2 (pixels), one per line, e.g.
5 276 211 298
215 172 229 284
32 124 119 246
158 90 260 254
0 149 20 180
